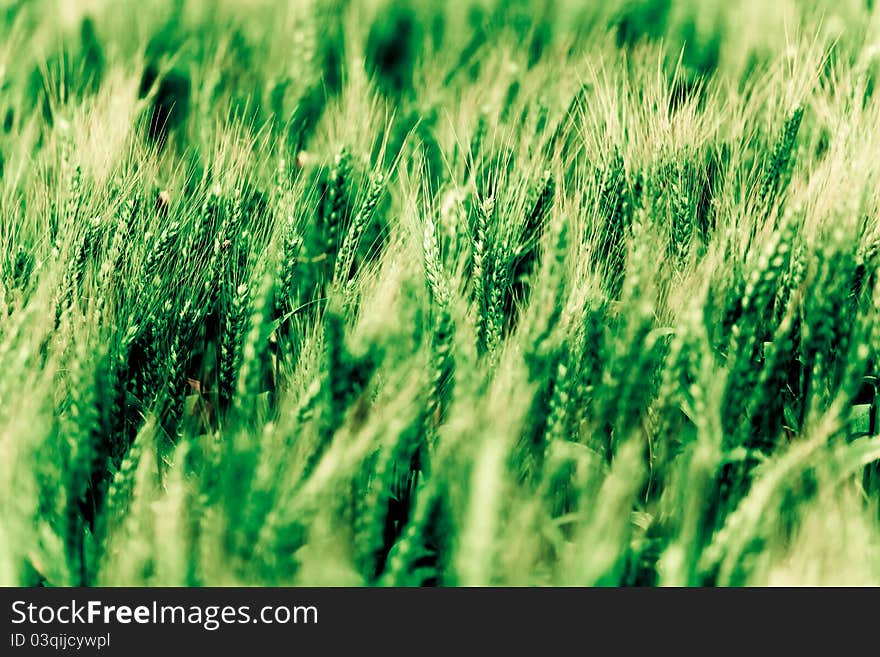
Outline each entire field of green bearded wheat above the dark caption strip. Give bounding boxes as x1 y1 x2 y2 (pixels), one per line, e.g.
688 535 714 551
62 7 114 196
0 0 880 586
